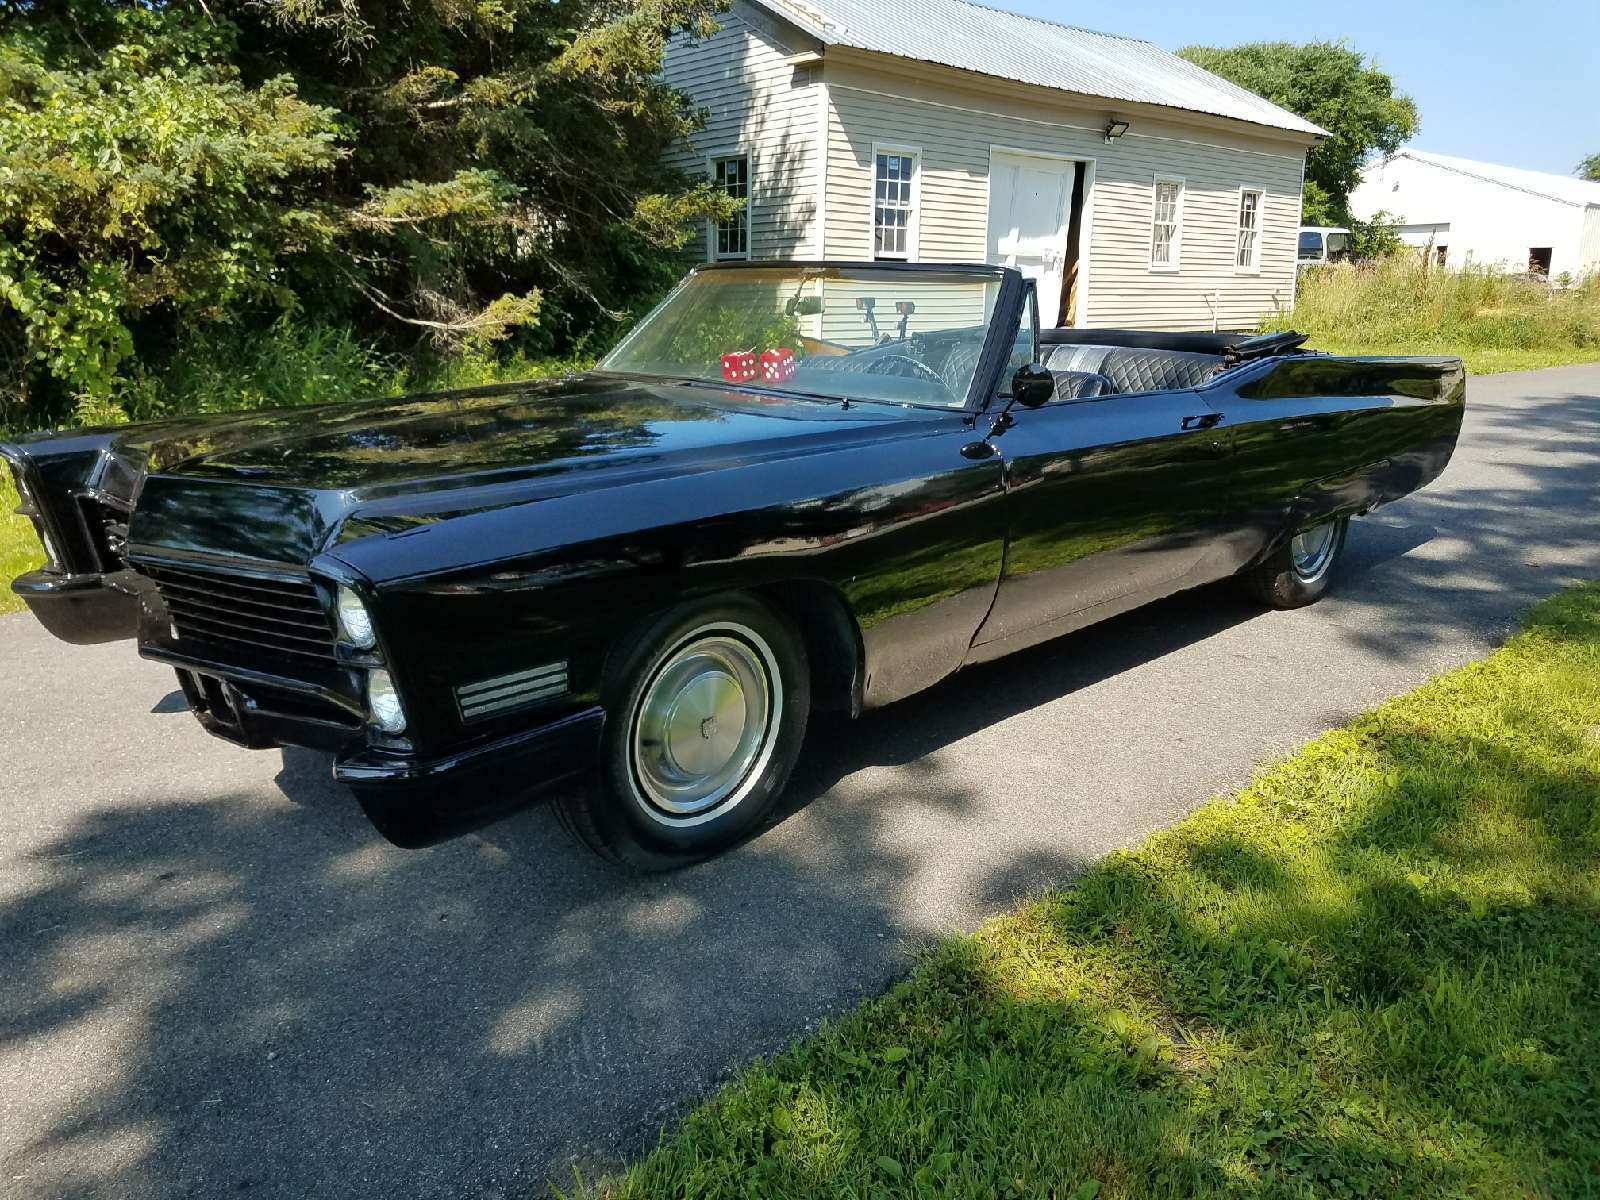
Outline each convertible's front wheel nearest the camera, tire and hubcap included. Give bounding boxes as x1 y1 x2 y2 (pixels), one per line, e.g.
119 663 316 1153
557 595 811 870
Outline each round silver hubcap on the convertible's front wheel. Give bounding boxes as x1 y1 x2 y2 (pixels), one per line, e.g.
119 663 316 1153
630 626 782 824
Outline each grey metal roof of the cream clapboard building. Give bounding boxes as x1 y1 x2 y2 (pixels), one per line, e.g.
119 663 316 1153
752 0 1328 136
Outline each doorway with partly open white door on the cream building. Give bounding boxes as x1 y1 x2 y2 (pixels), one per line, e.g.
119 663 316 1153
989 149 1088 326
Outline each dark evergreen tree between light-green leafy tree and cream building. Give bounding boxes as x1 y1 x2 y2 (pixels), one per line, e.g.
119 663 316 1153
233 0 722 346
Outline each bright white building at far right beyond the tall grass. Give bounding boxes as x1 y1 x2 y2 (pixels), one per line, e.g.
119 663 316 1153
1350 149 1600 280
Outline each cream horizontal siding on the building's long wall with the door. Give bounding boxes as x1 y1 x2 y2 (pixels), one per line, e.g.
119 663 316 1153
826 70 1302 330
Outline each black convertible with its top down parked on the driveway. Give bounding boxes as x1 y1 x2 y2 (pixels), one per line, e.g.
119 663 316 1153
0 262 1466 867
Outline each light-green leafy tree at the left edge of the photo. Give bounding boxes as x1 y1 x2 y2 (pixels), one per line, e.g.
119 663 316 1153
0 8 339 422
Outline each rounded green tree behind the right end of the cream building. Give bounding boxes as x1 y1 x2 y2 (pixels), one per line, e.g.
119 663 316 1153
1178 42 1418 224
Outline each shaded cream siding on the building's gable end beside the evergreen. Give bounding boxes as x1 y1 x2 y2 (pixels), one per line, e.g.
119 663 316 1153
662 11 821 259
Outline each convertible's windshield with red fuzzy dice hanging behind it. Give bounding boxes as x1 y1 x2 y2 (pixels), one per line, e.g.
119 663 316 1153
600 266 1002 408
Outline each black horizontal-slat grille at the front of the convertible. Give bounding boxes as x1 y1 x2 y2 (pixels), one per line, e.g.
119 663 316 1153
139 563 334 662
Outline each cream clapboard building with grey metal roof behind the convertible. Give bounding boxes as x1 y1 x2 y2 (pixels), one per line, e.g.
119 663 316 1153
666 0 1323 330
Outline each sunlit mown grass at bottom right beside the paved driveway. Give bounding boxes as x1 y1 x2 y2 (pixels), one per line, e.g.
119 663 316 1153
578 584 1600 1200
